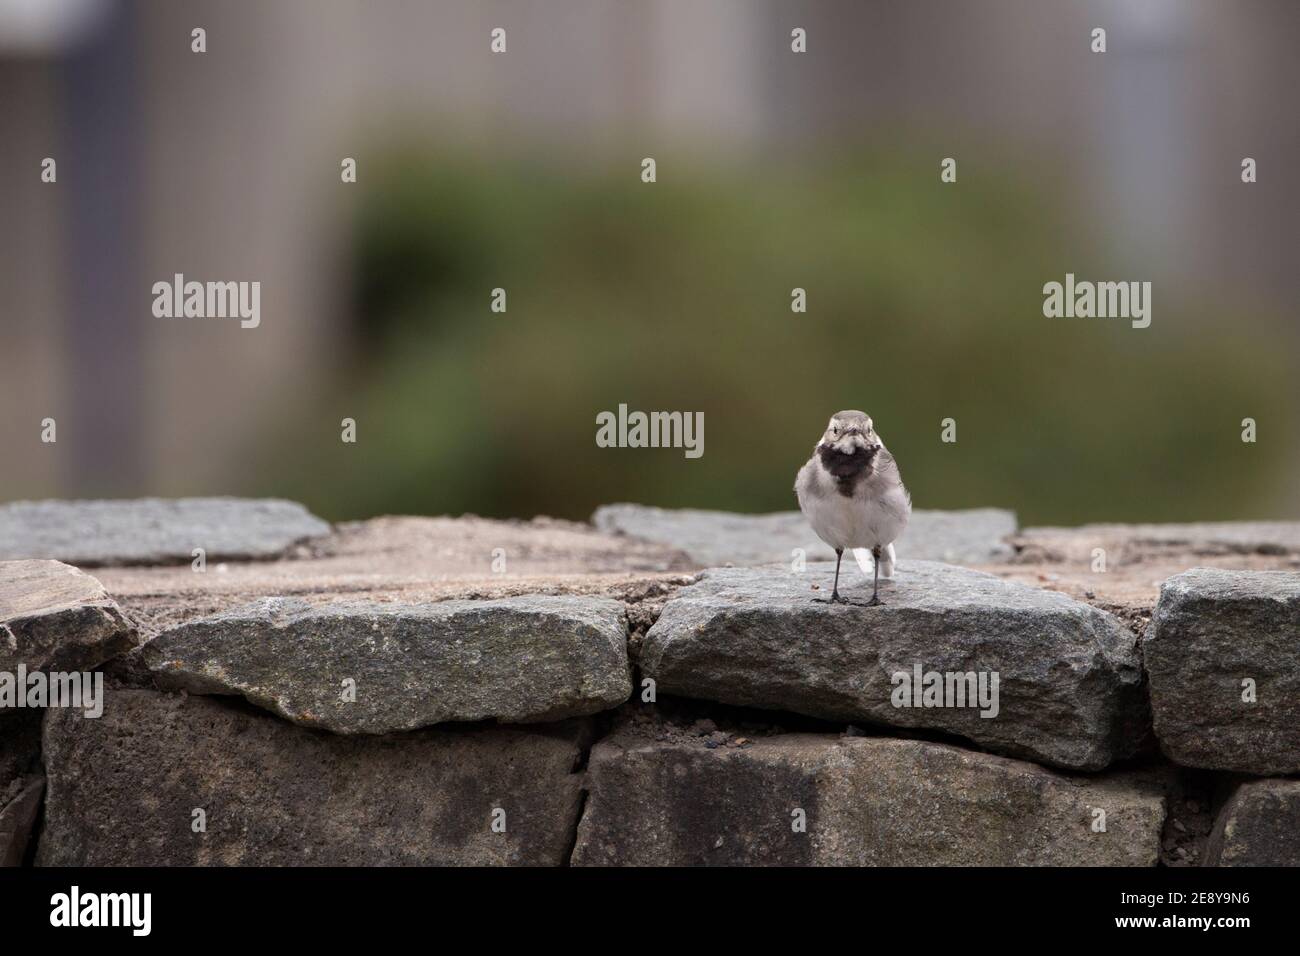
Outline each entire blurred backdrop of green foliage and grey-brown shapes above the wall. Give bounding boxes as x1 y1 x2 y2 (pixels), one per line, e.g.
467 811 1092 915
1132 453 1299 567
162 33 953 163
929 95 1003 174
0 0 1300 524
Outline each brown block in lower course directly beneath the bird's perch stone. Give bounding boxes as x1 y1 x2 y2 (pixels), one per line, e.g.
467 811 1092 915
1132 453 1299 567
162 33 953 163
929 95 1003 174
573 734 1165 866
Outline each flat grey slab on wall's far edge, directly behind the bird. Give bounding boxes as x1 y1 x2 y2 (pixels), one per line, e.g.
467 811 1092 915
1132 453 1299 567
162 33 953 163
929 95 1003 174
592 505 1017 567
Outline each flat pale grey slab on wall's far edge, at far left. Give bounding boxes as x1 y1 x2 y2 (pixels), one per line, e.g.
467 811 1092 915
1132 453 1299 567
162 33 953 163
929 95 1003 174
0 498 330 567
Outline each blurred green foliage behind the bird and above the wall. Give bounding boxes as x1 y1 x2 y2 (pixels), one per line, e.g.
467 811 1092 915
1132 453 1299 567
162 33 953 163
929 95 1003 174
253 148 1296 524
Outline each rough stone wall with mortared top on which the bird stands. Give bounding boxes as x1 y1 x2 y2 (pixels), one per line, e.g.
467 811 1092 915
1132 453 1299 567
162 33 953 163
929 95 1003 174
0 499 1300 866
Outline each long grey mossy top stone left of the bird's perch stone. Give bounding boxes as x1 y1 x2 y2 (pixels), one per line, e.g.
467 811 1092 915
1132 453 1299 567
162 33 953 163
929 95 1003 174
143 596 632 734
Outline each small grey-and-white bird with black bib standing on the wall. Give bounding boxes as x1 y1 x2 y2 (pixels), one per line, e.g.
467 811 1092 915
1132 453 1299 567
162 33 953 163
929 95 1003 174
794 410 911 607
